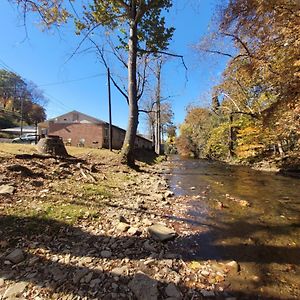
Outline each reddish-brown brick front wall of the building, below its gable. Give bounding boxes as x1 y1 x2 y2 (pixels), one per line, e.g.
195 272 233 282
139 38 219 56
48 123 103 148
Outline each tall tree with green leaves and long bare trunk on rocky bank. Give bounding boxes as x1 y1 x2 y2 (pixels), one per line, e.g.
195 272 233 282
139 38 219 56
14 0 174 165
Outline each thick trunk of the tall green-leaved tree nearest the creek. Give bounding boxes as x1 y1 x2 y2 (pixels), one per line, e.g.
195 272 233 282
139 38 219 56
121 13 138 166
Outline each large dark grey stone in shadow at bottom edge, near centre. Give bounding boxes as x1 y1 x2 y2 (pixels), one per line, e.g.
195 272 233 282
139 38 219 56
128 273 158 300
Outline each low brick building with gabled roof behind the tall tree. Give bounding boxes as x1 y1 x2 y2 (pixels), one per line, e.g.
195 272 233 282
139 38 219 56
38 110 152 150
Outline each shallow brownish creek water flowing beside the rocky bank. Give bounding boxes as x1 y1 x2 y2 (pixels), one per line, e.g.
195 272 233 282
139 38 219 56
168 157 300 299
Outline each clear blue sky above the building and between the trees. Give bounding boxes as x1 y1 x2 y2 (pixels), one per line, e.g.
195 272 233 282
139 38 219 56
0 0 224 132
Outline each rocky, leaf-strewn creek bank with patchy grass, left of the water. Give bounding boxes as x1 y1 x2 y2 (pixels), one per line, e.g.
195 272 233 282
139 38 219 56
0 148 239 300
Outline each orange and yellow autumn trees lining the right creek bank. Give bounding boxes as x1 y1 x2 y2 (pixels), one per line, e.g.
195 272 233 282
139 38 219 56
177 0 300 169
